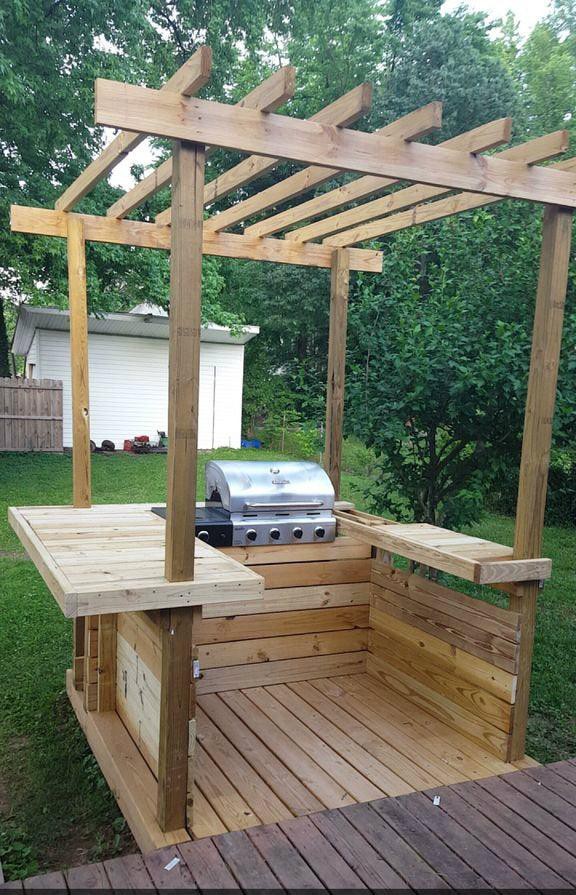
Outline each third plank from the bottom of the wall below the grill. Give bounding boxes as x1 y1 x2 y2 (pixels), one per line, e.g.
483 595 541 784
198 606 369 644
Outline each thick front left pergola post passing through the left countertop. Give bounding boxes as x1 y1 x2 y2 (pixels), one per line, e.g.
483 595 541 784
157 142 205 831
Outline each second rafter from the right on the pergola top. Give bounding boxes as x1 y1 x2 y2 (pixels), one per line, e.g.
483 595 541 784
322 130 569 246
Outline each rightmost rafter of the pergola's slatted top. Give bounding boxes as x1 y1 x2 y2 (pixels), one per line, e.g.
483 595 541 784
328 144 576 246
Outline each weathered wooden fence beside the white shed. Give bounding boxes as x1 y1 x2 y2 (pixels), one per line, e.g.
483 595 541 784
0 379 63 451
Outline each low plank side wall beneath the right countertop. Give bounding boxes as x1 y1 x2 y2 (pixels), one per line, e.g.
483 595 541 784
367 560 520 760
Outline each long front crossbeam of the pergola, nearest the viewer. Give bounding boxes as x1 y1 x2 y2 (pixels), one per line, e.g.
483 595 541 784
96 80 576 208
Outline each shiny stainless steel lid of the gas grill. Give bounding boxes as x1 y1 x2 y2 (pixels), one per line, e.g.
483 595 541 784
206 460 334 515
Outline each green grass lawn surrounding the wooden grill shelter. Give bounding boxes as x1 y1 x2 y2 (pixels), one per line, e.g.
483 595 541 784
0 450 576 878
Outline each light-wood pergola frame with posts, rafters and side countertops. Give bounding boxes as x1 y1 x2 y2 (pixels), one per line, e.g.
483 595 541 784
11 47 576 847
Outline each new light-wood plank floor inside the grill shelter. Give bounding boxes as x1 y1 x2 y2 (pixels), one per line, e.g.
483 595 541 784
193 674 532 838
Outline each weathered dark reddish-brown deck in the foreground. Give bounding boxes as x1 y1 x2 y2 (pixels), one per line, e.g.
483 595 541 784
7 761 576 891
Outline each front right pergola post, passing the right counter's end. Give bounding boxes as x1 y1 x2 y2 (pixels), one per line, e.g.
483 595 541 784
509 206 573 761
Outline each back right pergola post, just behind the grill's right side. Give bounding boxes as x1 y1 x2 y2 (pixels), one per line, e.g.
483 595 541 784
324 249 350 497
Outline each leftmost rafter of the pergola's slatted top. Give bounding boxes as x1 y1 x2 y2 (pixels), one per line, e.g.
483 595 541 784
55 47 212 211
